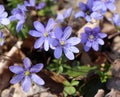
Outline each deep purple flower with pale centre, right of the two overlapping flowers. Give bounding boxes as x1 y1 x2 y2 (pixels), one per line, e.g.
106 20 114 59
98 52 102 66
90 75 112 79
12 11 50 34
81 27 107 51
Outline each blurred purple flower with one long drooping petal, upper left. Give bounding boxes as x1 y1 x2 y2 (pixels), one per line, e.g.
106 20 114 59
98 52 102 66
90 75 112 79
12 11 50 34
9 4 27 32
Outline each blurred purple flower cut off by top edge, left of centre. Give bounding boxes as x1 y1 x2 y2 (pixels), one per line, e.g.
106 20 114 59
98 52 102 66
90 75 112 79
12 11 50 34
24 0 46 10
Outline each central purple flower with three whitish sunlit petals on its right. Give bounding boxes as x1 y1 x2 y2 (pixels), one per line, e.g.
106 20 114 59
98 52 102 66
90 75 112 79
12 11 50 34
53 26 80 60
